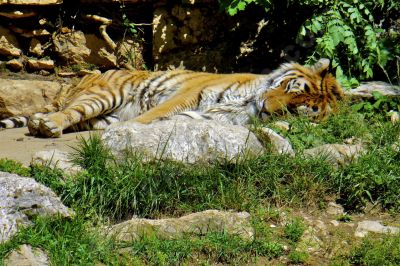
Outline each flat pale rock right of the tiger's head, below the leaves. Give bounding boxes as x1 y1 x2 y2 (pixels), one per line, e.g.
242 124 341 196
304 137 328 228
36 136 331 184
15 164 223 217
345 81 400 98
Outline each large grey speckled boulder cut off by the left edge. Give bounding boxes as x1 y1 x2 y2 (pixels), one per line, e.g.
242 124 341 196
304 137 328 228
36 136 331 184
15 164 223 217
0 172 74 243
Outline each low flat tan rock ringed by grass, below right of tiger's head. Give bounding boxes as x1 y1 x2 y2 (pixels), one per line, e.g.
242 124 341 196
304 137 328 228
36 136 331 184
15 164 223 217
304 144 364 164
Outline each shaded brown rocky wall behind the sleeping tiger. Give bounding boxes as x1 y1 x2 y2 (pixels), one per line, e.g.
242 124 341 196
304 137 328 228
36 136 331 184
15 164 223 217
0 0 328 76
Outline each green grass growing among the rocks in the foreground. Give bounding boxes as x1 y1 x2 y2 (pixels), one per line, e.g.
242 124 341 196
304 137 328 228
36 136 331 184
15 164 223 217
0 100 400 265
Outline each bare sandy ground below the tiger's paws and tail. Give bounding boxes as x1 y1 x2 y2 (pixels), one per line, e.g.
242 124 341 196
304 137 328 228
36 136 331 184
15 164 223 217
0 128 89 166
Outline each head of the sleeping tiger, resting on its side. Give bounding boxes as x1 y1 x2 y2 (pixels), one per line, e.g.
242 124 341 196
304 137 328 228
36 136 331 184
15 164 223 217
261 58 344 119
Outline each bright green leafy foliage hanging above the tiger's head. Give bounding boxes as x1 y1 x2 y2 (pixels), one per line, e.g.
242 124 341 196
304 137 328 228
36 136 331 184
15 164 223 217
220 0 400 87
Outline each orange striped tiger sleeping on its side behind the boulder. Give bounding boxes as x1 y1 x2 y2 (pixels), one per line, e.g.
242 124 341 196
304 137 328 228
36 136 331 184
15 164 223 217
0 59 343 138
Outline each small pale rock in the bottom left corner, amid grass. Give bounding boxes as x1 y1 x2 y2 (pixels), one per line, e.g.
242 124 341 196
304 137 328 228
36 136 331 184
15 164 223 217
4 245 50 266
